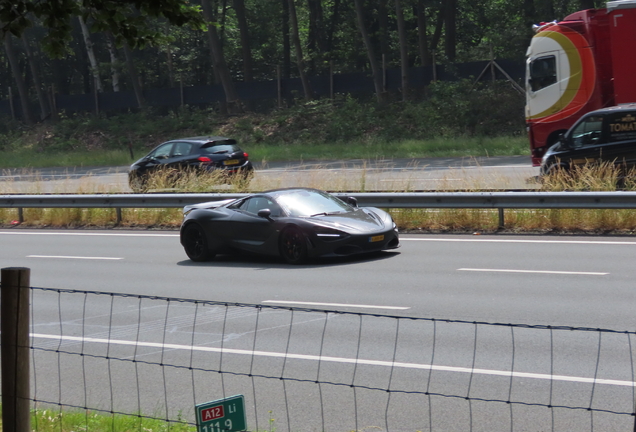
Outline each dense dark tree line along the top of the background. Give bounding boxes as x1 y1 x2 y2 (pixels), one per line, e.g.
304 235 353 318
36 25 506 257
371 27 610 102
0 0 604 121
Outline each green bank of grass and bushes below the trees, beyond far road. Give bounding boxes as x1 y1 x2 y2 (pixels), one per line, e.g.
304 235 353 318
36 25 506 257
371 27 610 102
0 81 529 168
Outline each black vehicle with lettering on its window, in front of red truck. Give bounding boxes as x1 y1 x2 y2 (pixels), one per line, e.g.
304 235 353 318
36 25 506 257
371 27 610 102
541 104 636 175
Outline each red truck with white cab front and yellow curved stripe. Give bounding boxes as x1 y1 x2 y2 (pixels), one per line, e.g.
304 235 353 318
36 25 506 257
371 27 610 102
526 0 636 166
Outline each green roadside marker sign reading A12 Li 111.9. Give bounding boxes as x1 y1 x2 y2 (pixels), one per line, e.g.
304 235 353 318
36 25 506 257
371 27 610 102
195 395 247 432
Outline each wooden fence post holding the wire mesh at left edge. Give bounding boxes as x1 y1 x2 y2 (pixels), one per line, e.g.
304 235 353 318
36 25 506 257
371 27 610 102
0 267 31 432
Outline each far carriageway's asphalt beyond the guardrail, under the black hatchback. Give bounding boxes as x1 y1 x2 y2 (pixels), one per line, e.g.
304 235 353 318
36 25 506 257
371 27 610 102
0 156 539 193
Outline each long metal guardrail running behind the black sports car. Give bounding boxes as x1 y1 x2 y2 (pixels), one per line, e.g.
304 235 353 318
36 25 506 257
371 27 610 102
0 192 636 226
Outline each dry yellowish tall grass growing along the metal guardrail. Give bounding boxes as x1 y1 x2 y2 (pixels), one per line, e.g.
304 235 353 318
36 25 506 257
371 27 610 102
0 163 636 234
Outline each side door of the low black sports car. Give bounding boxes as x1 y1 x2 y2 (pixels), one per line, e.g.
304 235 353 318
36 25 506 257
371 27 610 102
226 195 282 254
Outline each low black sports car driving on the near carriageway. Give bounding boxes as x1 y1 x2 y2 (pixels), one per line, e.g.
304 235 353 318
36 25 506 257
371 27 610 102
181 188 400 264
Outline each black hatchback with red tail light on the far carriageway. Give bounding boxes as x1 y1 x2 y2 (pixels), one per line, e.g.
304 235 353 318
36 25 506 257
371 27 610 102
128 136 254 192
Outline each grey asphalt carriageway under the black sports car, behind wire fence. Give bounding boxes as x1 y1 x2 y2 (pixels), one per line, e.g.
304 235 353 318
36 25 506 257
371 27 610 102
0 229 636 431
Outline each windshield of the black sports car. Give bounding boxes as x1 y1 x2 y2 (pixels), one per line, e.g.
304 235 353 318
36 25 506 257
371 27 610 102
275 189 352 217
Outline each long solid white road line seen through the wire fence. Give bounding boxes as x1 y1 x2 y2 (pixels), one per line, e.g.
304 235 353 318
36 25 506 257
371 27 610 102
31 333 636 387
